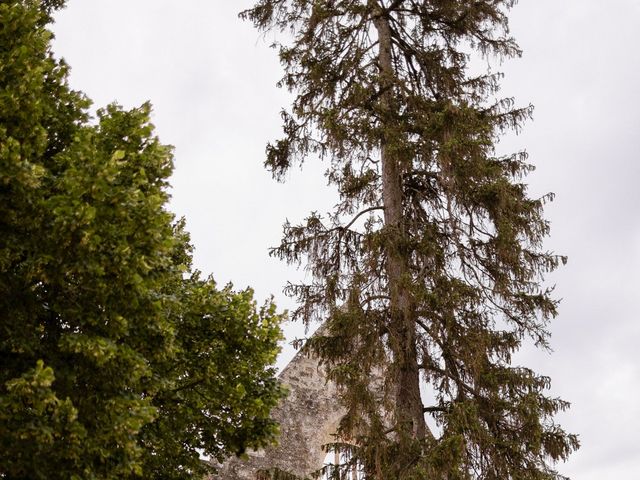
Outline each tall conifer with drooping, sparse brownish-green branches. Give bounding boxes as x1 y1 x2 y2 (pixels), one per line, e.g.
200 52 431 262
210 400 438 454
241 0 578 480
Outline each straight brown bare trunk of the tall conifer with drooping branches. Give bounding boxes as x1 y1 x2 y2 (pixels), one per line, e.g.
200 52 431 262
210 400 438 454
374 3 427 451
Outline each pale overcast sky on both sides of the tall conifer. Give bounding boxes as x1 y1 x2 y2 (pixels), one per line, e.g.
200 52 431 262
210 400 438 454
53 0 640 480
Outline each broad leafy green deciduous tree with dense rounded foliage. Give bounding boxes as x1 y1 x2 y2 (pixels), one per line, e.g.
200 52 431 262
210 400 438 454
0 0 281 480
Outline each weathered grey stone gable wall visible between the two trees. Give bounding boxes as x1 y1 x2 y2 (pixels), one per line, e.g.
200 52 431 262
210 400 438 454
210 346 344 480
